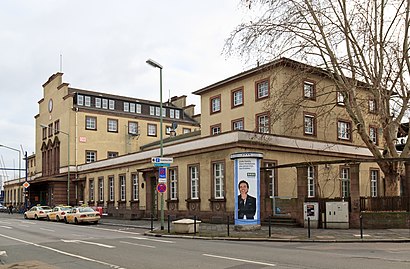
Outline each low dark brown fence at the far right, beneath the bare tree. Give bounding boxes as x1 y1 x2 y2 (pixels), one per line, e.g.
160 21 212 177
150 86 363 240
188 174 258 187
360 196 410 212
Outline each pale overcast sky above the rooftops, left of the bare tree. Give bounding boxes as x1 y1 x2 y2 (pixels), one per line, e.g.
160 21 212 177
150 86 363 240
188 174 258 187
0 0 252 181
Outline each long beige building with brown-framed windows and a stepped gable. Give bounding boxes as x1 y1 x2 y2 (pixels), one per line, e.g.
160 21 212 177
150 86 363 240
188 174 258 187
3 59 390 224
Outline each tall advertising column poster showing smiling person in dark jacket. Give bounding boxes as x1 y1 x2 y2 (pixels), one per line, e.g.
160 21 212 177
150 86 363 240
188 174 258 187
234 158 260 225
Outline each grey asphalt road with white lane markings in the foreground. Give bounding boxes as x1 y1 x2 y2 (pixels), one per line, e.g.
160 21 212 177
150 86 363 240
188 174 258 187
0 213 410 269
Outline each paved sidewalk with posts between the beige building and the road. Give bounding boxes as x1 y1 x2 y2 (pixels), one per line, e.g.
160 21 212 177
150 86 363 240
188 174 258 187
100 217 410 242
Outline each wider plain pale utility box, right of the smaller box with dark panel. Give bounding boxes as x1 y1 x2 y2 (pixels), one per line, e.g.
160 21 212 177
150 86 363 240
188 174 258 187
326 202 349 229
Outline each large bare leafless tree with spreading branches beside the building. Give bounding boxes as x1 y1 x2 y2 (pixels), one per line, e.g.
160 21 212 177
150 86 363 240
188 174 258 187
225 0 410 196
